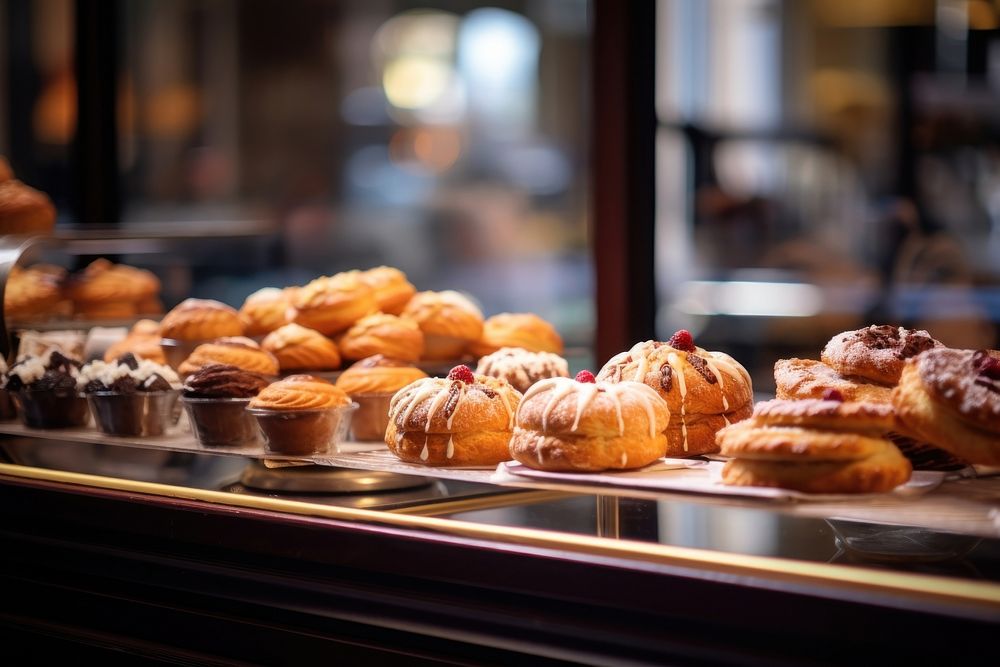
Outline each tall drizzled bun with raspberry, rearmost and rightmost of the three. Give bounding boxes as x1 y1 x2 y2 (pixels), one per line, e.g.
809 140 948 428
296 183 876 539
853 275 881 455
597 329 753 457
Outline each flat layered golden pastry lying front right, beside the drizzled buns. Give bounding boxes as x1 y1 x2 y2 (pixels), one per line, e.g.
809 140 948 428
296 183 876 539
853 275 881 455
717 395 912 493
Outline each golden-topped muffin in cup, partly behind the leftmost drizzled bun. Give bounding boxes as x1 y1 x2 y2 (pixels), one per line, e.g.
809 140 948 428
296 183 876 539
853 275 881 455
337 354 427 440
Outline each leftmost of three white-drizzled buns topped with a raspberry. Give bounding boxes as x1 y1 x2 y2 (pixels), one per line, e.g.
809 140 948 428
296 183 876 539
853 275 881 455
385 366 521 466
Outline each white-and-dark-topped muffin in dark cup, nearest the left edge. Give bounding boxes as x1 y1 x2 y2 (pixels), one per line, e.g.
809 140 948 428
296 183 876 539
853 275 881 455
5 349 90 428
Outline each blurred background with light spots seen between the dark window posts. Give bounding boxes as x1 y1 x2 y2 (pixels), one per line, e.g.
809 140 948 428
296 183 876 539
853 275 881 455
0 0 1000 391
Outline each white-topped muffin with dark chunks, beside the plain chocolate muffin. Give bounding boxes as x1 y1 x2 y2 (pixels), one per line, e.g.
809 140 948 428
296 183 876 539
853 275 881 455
77 353 181 436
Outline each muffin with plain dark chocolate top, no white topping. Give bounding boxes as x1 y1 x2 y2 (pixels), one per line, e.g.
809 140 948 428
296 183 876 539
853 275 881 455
181 364 268 447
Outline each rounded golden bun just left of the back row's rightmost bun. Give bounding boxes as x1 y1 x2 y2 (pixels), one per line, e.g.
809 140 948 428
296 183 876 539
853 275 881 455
402 290 483 360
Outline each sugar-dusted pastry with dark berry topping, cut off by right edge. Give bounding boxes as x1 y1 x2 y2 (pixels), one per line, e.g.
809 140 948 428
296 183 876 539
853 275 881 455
892 348 1000 465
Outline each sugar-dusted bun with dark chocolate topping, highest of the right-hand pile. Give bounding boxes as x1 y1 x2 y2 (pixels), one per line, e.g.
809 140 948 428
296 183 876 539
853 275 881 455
820 325 943 385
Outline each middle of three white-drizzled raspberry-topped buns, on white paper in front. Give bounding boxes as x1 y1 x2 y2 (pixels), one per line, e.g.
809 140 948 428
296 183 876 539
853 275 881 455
510 373 670 472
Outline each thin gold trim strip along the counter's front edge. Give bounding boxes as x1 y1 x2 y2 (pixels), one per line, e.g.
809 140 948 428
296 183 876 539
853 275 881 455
0 463 1000 610
